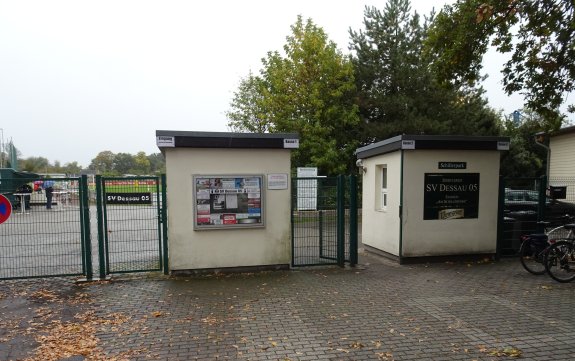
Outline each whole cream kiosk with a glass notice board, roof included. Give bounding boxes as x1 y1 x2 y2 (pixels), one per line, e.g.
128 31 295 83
156 130 299 273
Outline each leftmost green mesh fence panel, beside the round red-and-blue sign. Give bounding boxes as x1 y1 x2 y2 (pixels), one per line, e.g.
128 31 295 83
0 178 90 279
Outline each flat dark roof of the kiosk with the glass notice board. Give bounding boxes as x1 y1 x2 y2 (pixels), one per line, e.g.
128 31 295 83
156 130 299 150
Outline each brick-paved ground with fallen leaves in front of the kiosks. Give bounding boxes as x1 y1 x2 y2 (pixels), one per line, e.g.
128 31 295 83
0 255 575 361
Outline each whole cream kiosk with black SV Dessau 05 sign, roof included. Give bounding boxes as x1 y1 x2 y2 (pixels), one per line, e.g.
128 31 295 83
356 135 509 263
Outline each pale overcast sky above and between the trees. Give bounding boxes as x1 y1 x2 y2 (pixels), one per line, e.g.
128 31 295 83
0 0 540 167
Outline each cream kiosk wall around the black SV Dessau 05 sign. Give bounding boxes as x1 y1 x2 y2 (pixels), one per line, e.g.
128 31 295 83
402 150 500 257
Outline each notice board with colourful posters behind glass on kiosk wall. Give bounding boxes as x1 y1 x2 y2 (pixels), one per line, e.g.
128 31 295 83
194 175 264 229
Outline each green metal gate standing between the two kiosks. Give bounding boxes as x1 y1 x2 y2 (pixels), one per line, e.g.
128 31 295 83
291 175 358 267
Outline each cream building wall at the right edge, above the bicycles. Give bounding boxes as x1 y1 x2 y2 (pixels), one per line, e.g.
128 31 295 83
549 133 575 178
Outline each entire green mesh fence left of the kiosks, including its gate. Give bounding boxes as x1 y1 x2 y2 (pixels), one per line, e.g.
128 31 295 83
0 176 168 279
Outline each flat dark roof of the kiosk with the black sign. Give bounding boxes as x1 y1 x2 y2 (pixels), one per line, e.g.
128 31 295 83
355 134 509 158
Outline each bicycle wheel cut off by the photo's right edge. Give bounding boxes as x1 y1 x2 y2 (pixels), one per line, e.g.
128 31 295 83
545 241 575 282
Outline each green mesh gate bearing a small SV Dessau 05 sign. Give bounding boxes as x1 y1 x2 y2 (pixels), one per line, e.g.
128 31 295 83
96 176 167 278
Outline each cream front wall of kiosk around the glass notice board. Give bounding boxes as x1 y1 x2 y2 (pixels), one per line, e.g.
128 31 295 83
164 148 291 270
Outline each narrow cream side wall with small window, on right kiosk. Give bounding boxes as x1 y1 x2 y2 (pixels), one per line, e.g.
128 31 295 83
361 151 401 256
